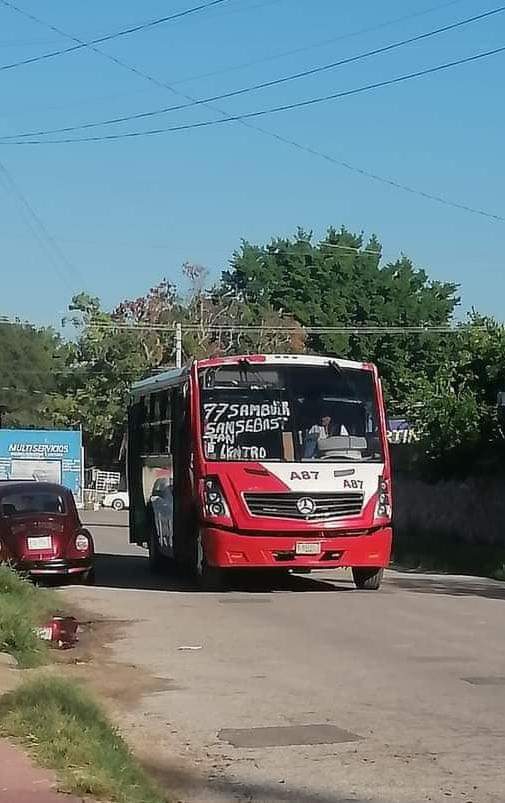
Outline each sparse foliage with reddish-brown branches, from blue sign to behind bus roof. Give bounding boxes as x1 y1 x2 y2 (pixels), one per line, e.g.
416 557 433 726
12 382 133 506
52 264 303 463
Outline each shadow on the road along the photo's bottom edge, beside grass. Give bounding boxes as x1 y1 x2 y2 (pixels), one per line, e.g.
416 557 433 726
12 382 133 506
143 761 373 803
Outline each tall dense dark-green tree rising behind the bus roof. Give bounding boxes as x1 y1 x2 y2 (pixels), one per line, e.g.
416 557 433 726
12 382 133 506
221 228 459 412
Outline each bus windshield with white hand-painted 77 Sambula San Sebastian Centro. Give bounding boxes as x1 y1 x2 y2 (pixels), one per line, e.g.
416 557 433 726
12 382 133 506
200 361 383 462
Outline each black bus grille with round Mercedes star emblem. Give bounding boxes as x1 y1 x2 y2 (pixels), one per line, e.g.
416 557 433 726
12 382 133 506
244 493 363 521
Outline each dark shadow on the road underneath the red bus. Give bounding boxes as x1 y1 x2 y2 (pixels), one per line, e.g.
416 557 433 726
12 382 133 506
95 550 346 594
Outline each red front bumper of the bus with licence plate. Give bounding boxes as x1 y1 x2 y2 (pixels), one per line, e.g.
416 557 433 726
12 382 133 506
202 527 392 569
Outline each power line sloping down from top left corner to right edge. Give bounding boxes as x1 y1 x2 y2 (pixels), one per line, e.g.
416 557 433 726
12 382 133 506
4 7 505 223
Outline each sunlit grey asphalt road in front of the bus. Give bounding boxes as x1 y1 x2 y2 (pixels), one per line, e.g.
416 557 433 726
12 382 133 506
64 511 505 803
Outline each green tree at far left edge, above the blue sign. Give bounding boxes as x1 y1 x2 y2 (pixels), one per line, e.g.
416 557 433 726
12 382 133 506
0 323 64 428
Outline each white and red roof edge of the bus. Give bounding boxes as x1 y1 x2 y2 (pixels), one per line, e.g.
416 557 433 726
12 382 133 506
131 354 373 398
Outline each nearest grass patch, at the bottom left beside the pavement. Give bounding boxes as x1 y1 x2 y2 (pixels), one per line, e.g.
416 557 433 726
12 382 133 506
0 677 167 803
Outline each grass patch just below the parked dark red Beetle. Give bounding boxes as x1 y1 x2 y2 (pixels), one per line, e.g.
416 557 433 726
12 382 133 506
0 565 57 667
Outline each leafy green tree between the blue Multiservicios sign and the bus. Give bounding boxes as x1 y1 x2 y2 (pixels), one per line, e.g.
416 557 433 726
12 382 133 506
53 282 177 464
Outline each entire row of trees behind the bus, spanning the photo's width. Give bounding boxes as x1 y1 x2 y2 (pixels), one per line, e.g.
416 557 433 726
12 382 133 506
0 228 505 476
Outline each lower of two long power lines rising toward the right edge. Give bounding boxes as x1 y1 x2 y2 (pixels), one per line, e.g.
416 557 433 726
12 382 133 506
5 42 505 145
